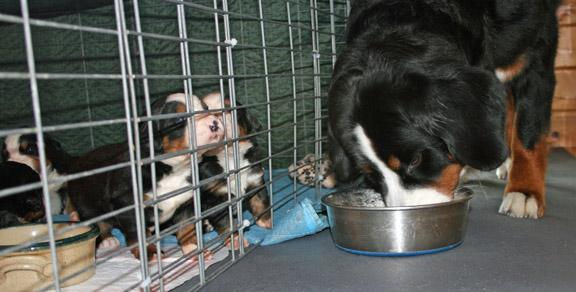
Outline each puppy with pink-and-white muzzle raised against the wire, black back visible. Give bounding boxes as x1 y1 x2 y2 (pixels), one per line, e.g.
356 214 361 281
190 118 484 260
68 93 224 260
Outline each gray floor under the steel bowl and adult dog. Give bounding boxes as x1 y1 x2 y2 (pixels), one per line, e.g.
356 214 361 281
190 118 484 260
195 149 576 291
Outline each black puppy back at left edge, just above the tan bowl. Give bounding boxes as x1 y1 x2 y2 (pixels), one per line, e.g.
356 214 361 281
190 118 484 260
0 161 44 227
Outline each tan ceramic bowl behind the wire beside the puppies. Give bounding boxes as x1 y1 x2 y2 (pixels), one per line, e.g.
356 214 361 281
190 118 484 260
0 222 100 292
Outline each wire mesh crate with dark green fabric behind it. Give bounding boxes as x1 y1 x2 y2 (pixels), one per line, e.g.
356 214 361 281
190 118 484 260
0 0 349 291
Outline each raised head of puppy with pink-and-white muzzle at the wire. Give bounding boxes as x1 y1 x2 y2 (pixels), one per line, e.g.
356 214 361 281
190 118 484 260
148 93 224 155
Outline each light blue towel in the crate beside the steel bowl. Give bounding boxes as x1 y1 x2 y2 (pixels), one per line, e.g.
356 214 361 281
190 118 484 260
54 169 332 245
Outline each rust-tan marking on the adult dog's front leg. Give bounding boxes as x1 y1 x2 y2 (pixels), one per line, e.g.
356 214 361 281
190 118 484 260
504 94 549 217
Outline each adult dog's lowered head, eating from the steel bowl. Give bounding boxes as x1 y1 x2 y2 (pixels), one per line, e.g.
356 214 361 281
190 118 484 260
329 56 507 206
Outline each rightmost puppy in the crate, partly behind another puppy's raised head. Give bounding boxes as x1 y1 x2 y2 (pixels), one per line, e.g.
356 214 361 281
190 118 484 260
171 93 272 248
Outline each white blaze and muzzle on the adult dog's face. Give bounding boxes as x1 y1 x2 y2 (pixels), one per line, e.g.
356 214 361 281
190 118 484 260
354 126 450 207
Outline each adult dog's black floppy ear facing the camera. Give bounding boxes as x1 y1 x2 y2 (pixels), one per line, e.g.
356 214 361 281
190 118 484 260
430 68 508 170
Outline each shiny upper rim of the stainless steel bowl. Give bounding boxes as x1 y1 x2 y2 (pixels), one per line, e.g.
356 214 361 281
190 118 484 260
321 187 474 211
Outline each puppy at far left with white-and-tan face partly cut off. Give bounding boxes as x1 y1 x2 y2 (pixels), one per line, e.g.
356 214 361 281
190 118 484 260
2 134 77 220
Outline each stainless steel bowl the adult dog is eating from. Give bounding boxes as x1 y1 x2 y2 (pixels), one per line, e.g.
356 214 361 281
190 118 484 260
322 188 474 256
